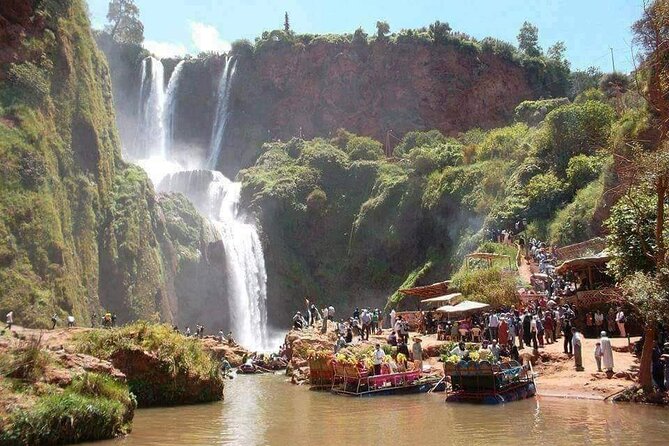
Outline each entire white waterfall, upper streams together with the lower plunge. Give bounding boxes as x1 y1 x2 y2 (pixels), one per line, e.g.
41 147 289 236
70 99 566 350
125 57 279 350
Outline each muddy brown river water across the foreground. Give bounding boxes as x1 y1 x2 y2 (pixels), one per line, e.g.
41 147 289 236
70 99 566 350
93 375 669 446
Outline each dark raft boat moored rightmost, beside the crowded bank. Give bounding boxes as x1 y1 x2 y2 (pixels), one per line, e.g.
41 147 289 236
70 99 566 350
444 361 536 404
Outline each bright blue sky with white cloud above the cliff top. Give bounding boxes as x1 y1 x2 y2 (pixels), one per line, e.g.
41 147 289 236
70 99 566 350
88 0 642 71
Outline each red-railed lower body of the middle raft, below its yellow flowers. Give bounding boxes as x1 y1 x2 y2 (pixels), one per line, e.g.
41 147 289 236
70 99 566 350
330 361 445 396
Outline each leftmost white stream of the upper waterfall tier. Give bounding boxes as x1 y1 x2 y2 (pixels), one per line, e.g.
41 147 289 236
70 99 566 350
139 56 166 158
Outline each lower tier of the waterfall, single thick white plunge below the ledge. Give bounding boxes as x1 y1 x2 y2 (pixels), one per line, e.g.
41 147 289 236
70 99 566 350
158 170 269 350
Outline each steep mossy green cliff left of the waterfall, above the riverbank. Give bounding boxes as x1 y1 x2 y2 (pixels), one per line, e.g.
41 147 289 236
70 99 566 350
0 0 224 326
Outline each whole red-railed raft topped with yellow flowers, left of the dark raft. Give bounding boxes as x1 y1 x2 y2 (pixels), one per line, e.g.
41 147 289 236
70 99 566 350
330 353 445 396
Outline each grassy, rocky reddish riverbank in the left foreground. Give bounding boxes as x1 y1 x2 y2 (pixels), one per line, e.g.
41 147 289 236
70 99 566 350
0 322 237 445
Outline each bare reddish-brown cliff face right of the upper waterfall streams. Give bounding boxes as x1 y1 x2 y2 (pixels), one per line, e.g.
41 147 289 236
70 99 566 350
213 43 537 175
